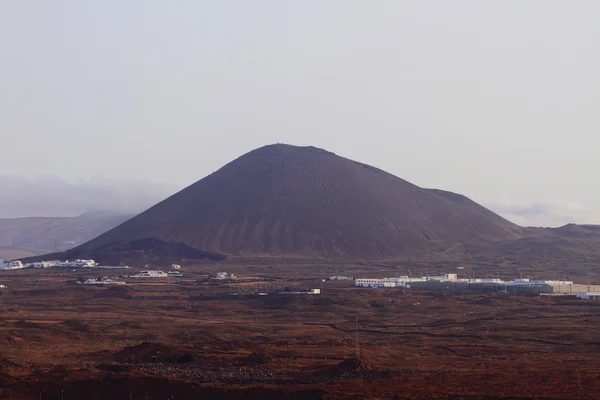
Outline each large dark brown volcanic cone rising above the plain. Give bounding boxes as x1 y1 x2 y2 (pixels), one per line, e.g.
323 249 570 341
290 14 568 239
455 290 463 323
41 144 522 258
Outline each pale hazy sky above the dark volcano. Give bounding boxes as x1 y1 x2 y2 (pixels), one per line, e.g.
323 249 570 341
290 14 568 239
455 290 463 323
0 0 600 225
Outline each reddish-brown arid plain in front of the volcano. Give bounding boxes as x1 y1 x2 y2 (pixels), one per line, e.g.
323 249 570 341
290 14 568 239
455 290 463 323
0 260 600 399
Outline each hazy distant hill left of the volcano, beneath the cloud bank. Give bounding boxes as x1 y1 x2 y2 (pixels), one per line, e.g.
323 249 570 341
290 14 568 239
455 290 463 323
0 212 131 259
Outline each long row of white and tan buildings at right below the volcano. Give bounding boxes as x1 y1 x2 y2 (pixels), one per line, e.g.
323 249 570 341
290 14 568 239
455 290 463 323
354 274 600 299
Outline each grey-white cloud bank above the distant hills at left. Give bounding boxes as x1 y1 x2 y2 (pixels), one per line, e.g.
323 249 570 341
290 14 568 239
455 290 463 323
0 175 178 218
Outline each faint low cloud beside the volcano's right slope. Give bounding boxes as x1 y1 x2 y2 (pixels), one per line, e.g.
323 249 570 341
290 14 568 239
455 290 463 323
486 202 600 227
